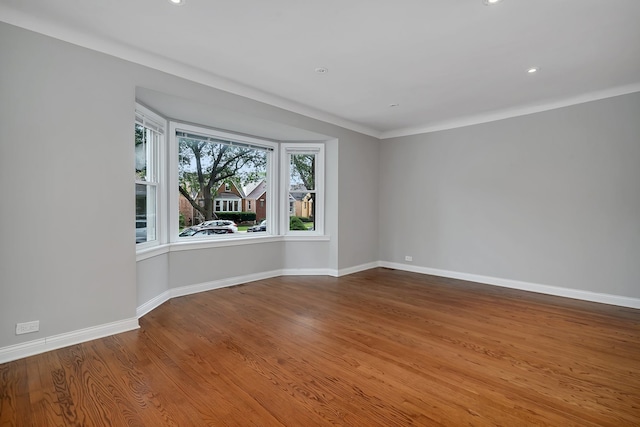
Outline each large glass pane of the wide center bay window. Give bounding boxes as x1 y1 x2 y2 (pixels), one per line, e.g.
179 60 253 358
176 131 271 237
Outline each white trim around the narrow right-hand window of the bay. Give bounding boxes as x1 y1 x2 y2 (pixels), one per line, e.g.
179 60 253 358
280 142 325 236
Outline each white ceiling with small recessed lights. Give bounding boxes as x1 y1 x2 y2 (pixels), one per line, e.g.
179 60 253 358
0 0 640 138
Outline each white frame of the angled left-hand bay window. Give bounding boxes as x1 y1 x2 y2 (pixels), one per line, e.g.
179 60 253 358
134 102 167 252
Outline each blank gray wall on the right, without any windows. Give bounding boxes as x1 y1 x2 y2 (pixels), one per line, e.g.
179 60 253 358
379 93 640 298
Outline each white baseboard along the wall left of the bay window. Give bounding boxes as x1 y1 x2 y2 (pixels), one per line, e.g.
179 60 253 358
0 318 140 363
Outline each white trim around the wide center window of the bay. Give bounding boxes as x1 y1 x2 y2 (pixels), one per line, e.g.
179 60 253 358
167 121 279 245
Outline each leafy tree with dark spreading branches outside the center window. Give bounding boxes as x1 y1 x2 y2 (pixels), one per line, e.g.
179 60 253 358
178 138 266 221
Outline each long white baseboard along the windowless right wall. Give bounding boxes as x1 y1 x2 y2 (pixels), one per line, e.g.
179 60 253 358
378 261 640 309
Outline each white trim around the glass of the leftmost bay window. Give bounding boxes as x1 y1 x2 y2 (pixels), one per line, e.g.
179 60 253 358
134 102 167 252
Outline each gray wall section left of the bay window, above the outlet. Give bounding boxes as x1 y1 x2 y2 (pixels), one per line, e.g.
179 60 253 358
0 24 136 347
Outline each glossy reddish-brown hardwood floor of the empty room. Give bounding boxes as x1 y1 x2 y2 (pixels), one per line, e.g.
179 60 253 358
0 269 640 427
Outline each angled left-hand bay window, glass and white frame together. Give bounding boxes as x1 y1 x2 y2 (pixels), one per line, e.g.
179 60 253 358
134 104 165 247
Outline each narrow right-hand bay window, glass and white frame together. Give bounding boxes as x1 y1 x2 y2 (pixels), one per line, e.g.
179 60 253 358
281 143 324 234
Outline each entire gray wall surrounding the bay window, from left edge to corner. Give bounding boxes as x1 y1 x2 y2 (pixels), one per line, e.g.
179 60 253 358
0 23 379 349
